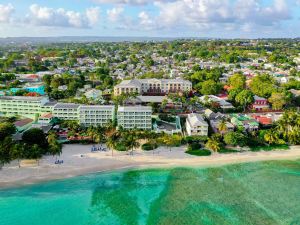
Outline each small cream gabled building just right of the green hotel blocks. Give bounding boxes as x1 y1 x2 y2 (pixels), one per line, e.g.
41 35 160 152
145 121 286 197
186 113 208 136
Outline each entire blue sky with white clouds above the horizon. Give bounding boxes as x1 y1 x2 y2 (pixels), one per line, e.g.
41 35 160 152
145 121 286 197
0 0 300 38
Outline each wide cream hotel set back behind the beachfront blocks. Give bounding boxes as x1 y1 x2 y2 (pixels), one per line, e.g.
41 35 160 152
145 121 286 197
114 79 192 96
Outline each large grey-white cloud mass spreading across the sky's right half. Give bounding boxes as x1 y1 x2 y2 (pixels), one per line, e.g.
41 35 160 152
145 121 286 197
134 0 291 31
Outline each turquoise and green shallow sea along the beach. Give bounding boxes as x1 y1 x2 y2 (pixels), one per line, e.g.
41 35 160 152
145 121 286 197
0 160 300 225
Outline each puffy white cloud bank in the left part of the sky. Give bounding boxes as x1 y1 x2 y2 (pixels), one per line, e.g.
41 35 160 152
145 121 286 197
26 4 100 28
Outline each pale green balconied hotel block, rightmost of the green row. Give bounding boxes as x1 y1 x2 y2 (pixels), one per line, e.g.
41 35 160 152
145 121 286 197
117 106 152 130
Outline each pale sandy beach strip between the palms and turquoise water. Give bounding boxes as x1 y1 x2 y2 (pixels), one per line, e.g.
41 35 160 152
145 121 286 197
0 145 300 188
